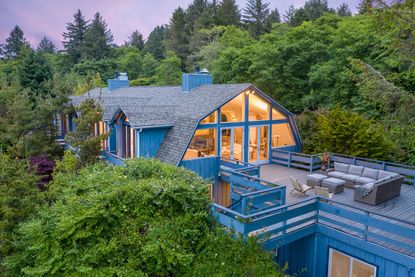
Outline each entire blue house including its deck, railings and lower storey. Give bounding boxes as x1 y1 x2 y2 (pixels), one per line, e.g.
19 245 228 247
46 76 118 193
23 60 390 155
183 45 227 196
61 70 415 277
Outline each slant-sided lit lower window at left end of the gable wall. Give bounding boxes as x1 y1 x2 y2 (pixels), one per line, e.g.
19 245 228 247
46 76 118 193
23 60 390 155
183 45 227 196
183 128 216 160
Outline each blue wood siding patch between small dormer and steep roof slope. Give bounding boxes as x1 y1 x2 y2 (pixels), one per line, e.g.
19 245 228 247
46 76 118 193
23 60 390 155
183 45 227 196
137 128 168 158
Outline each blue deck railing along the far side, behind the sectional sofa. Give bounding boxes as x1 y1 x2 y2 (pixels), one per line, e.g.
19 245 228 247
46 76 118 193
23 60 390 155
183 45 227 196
271 148 415 185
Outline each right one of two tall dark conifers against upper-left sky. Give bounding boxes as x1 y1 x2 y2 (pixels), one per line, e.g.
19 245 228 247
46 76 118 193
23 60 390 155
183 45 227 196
83 12 114 60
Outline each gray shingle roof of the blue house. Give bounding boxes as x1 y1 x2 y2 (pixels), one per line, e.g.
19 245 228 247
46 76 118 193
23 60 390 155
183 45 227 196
72 84 251 165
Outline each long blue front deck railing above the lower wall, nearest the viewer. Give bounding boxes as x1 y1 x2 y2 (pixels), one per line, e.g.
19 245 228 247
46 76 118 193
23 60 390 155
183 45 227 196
211 196 415 255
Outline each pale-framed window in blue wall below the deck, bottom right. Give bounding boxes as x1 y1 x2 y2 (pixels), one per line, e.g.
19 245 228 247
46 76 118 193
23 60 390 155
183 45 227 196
328 248 376 277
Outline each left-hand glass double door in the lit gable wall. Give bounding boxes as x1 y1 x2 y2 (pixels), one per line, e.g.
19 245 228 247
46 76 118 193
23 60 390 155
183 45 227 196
221 128 244 161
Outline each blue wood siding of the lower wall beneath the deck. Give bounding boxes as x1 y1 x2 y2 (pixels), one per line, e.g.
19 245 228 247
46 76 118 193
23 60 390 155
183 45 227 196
278 233 415 277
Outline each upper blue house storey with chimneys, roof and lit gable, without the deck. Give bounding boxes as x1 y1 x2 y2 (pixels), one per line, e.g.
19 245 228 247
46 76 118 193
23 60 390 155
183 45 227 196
70 73 301 172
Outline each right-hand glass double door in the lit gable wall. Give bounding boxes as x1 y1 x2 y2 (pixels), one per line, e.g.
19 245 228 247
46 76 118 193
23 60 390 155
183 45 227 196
249 125 269 163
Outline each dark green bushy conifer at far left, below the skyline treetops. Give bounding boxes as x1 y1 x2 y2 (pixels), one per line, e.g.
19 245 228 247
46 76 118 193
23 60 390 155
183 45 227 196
19 50 52 95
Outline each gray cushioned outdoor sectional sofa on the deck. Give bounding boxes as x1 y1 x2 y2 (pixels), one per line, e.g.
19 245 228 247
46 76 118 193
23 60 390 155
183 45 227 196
328 162 404 206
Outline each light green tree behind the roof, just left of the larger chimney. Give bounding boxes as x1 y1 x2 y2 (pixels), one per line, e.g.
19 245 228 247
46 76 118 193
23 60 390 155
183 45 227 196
156 51 182 85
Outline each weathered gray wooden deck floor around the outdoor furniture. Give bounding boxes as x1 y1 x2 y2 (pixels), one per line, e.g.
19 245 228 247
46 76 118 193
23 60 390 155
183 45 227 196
260 164 415 224
